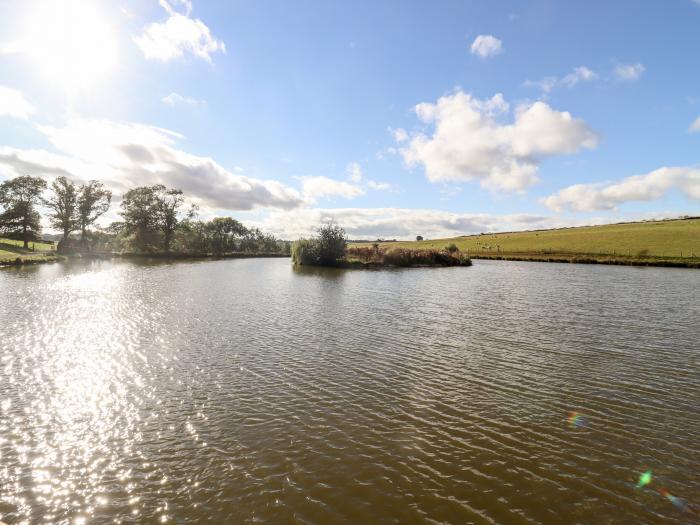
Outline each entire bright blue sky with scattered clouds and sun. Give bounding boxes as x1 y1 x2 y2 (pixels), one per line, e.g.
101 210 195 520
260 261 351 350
0 0 700 239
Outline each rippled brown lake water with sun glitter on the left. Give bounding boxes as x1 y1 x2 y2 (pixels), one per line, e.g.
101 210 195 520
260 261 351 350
0 259 700 524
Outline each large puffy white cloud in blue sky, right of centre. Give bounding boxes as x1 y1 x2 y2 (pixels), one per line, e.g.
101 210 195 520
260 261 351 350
400 91 598 192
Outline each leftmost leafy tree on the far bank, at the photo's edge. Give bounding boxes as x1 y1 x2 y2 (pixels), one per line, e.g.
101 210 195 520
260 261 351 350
0 175 46 249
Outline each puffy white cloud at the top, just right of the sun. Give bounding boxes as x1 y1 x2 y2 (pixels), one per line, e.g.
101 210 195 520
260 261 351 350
134 0 226 62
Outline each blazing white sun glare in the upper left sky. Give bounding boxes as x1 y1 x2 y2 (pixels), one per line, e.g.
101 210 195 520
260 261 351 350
21 0 117 94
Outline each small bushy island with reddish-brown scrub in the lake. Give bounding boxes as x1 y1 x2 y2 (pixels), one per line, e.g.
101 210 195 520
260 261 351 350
292 223 472 268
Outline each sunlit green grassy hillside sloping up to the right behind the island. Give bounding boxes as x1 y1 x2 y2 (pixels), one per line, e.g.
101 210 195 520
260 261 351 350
362 219 700 263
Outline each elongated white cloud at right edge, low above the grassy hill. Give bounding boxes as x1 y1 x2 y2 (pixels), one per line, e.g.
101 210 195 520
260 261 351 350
542 167 700 212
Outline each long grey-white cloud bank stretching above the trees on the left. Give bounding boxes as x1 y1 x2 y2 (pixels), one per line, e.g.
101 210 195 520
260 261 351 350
0 119 305 211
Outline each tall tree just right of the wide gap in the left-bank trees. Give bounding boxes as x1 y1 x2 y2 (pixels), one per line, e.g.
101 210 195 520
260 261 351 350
121 184 165 251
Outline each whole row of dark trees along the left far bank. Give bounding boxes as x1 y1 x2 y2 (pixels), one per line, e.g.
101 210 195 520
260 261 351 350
0 175 289 254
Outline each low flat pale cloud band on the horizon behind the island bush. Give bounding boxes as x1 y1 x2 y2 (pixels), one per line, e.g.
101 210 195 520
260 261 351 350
257 208 570 239
